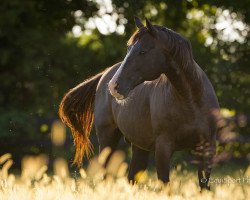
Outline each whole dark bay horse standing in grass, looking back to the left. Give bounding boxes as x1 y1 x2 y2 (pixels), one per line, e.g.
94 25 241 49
59 18 219 188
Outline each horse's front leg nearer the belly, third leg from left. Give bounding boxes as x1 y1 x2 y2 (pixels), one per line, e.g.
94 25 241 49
155 135 174 183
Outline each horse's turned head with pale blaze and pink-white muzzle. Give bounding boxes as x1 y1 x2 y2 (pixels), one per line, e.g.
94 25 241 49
108 17 166 100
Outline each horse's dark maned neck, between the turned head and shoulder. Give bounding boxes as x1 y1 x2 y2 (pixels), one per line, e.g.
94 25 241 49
161 33 203 106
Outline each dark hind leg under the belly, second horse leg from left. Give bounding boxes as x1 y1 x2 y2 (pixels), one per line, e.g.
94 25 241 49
128 144 150 183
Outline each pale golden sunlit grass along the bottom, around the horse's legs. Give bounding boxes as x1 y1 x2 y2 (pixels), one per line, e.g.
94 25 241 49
0 153 250 200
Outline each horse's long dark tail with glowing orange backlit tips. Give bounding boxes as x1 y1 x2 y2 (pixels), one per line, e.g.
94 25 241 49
59 71 105 167
